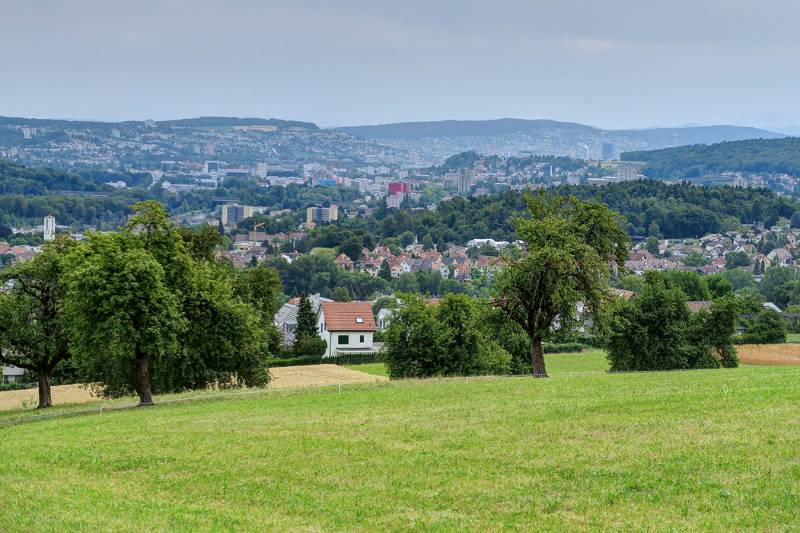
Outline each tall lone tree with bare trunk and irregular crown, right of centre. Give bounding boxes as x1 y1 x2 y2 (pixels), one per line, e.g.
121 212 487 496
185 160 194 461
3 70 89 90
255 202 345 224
496 193 628 377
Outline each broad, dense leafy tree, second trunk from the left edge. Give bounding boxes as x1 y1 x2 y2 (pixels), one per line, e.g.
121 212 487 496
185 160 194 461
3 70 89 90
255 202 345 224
67 234 184 405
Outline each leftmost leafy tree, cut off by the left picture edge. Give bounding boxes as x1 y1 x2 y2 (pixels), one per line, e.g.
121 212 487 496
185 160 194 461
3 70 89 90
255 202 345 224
0 236 75 409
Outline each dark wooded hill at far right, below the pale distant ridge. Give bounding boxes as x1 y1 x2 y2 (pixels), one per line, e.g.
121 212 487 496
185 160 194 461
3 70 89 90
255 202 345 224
621 137 800 179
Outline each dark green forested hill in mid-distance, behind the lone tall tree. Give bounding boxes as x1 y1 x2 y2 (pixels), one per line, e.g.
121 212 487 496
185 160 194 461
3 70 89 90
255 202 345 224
351 180 800 244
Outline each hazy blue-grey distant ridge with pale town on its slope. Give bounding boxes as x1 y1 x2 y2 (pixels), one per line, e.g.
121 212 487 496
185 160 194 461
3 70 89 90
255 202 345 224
338 118 784 164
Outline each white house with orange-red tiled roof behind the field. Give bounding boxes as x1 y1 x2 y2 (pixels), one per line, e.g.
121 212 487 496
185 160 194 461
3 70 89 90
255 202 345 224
317 302 377 357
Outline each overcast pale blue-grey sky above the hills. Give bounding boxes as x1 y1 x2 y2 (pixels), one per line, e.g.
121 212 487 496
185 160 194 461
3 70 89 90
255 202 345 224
0 0 800 128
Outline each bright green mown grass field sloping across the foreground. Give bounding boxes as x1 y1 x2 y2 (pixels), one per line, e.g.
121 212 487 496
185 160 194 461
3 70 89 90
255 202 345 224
0 354 800 531
